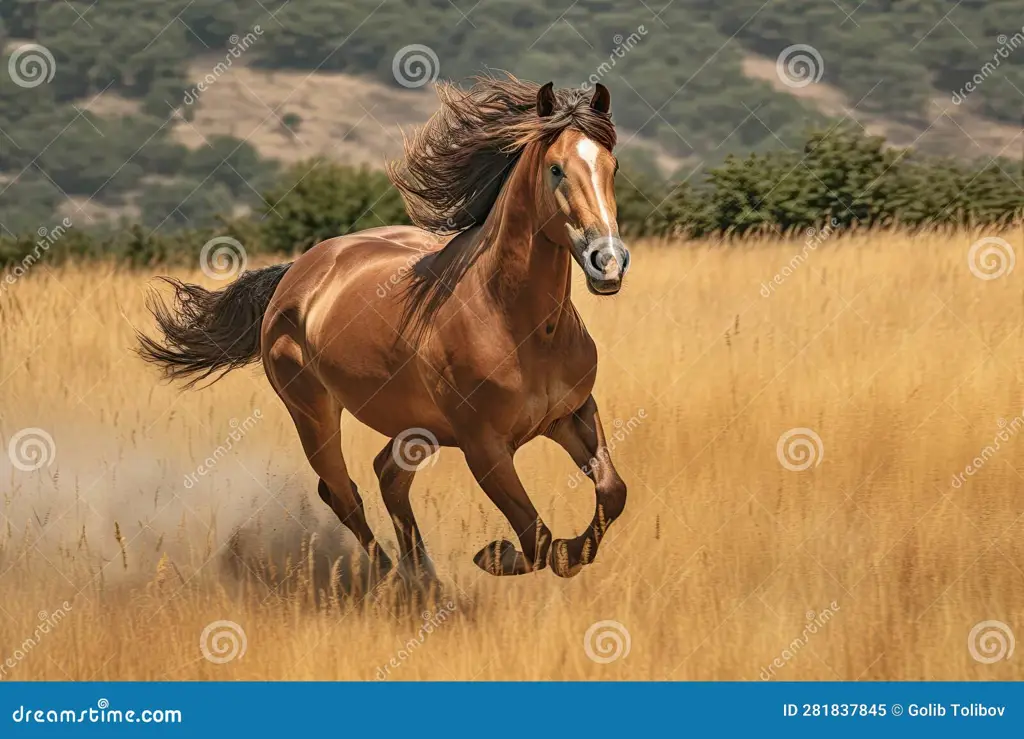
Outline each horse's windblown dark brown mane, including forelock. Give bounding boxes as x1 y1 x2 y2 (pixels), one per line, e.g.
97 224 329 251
388 75 615 330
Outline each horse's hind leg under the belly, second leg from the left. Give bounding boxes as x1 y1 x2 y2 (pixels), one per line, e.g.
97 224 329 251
374 439 437 581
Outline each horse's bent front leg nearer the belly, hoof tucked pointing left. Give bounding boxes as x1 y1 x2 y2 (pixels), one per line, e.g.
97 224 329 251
460 434 551 575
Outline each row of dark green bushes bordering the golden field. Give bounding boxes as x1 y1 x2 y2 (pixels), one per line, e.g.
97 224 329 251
0 130 1024 270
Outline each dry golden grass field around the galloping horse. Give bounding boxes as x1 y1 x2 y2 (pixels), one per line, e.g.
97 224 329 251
0 233 1024 680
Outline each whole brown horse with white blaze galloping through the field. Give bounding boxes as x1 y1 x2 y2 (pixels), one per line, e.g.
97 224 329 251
139 77 629 577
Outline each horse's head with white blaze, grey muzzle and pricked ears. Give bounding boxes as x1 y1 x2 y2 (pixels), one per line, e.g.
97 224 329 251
537 82 630 295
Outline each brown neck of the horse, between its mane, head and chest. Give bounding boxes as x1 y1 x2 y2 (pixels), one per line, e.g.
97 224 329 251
482 155 571 338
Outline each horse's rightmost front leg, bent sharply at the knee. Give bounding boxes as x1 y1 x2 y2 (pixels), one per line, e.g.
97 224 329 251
547 395 626 577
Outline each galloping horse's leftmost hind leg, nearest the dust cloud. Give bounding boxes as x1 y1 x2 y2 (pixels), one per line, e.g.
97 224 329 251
267 343 391 576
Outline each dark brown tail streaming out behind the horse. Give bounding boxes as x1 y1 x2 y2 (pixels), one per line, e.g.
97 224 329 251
136 263 292 387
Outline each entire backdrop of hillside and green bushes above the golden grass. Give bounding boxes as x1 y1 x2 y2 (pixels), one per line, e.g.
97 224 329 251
0 0 1024 251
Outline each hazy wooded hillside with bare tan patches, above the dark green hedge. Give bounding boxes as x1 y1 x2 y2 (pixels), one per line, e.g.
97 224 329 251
0 0 1024 233
